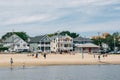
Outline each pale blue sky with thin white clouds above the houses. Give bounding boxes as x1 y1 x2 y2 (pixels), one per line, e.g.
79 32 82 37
0 0 120 37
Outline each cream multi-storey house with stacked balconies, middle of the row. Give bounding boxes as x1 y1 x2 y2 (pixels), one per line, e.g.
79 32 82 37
51 35 73 52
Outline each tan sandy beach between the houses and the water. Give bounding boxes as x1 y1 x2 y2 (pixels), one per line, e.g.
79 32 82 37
0 53 120 67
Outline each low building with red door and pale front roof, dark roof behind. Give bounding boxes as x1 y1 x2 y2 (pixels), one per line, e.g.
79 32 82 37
73 37 99 53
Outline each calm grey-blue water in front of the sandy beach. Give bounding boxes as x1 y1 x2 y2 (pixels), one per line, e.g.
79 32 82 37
0 65 120 80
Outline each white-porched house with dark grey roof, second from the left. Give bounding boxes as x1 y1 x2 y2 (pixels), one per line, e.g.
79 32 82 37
29 35 50 52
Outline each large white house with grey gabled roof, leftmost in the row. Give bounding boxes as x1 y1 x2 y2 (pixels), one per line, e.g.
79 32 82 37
3 34 29 52
